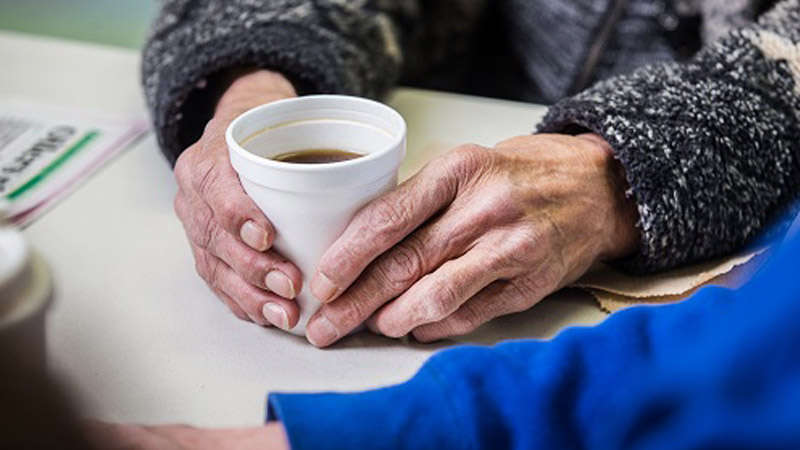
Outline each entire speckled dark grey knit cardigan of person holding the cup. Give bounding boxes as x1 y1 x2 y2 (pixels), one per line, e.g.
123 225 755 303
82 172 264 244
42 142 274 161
142 0 800 271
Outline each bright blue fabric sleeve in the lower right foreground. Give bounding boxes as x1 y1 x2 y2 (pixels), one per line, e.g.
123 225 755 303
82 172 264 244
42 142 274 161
268 225 800 450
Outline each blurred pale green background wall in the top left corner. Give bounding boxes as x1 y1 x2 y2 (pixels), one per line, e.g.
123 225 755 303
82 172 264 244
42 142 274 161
0 0 158 47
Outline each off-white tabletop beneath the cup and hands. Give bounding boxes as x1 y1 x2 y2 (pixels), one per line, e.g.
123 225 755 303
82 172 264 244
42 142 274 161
0 33 606 426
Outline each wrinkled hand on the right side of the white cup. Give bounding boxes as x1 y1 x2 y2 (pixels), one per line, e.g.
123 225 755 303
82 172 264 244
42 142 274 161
307 135 639 346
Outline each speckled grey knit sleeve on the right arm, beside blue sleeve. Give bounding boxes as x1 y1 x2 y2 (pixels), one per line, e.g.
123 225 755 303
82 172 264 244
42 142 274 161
539 0 800 272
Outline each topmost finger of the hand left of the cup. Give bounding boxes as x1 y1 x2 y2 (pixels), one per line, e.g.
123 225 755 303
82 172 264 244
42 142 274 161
175 133 275 251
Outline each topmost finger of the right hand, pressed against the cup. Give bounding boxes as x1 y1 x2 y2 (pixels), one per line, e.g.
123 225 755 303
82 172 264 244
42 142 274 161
310 146 487 303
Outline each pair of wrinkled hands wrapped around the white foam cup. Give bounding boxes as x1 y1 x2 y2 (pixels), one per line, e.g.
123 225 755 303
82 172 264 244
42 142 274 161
175 71 639 347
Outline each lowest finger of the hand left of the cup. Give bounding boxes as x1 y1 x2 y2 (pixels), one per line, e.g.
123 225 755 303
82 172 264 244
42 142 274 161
193 245 300 329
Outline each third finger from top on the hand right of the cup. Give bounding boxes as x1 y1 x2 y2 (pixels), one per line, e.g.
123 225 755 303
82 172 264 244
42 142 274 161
369 249 506 337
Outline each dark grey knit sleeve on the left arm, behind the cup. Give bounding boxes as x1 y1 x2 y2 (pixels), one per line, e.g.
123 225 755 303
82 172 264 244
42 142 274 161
142 0 484 162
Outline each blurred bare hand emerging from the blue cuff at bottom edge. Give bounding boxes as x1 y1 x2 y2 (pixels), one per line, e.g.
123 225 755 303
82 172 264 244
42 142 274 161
85 422 289 450
